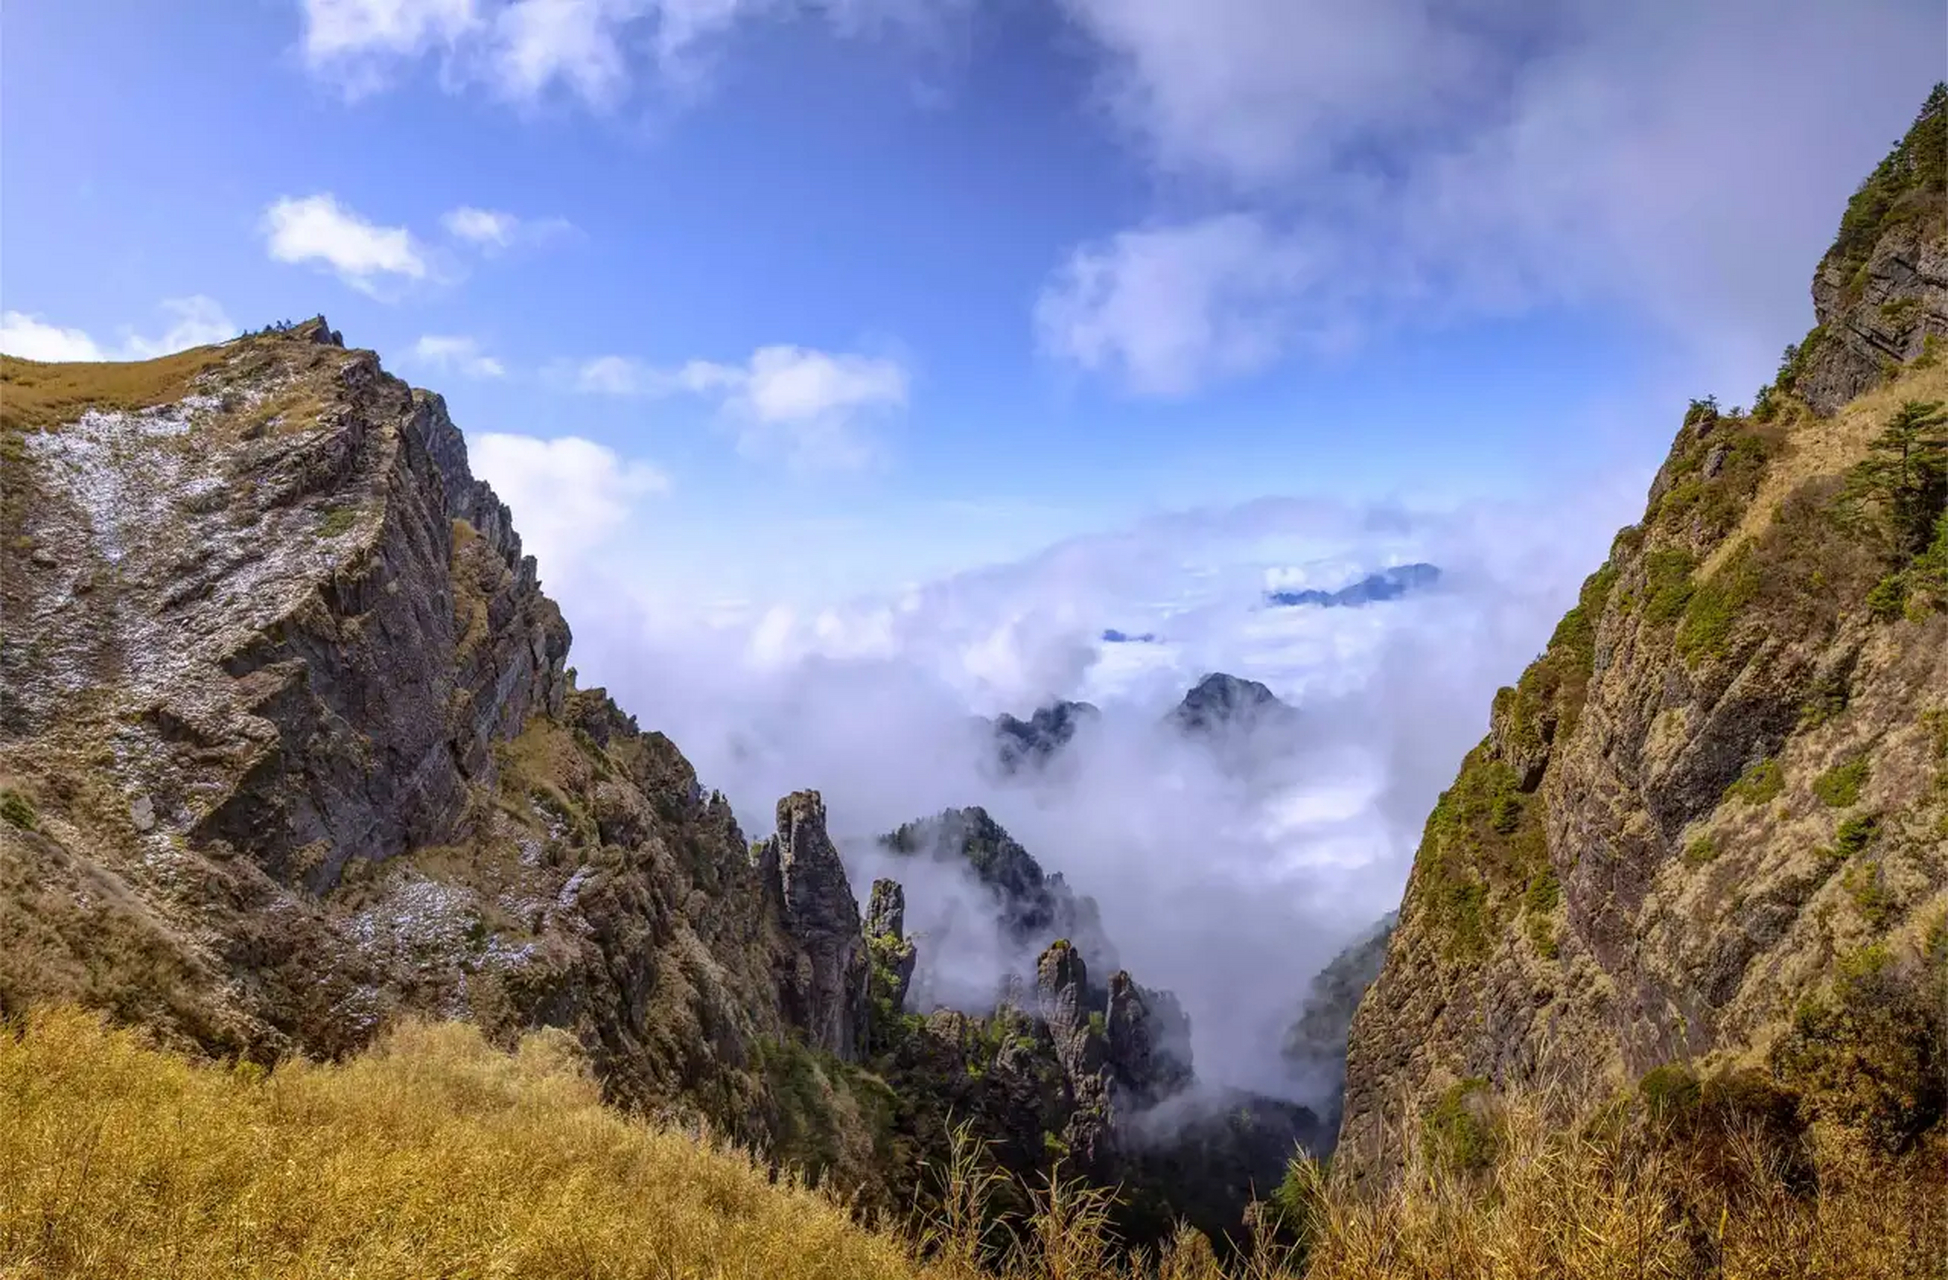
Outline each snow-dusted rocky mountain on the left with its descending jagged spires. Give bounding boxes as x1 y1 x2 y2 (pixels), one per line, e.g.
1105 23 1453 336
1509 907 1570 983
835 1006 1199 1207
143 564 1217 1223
0 318 1323 1239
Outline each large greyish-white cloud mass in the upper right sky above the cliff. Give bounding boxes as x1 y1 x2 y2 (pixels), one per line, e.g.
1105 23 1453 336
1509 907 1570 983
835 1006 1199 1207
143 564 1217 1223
1036 0 1942 394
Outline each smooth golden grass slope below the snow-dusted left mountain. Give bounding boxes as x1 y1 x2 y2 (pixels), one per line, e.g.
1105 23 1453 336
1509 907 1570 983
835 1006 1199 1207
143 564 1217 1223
0 1011 935 1280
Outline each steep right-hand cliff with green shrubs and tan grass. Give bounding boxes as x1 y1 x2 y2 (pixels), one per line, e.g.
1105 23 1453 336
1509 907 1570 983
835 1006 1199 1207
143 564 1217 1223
1338 88 1948 1173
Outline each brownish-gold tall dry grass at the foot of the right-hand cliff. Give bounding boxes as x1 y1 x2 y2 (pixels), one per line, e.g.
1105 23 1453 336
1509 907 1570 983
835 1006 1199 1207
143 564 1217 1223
1297 1099 1948 1280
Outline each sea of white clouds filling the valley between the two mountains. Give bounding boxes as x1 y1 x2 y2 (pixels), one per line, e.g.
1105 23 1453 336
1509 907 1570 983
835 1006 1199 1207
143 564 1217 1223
537 485 1640 1095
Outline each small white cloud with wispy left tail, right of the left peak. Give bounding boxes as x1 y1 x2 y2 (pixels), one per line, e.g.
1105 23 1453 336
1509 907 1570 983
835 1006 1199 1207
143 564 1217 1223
555 345 910 471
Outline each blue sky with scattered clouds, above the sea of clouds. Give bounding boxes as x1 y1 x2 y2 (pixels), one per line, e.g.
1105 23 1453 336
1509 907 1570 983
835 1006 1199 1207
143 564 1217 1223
0 0 1942 594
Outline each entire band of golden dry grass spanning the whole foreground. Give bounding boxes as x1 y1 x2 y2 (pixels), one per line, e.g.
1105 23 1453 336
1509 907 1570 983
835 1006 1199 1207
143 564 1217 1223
0 1009 1948 1280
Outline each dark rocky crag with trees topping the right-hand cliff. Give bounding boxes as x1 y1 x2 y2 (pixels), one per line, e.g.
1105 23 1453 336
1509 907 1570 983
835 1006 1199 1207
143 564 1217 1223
1780 92 1948 413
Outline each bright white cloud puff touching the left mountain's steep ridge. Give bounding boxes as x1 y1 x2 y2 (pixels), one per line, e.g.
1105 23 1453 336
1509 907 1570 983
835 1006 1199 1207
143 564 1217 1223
468 433 670 579
